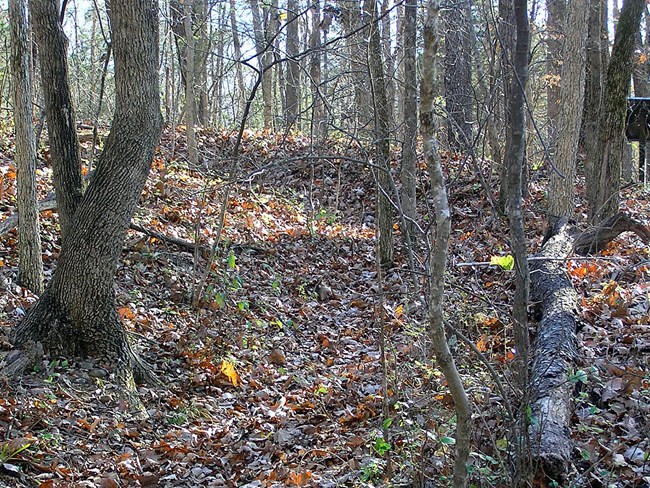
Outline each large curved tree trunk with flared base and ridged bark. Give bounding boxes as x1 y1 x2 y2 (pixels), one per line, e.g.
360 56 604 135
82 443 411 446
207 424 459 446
11 0 162 400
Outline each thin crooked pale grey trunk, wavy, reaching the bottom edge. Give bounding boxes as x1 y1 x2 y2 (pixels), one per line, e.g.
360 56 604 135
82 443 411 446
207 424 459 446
420 0 472 488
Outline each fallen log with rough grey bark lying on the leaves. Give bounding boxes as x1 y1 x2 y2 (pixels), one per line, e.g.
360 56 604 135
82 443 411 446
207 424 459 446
530 219 578 486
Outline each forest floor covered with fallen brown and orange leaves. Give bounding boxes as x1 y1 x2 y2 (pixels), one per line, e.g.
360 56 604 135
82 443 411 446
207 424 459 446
0 130 650 488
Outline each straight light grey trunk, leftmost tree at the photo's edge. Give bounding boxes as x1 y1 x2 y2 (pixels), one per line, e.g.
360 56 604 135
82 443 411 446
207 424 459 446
9 0 43 294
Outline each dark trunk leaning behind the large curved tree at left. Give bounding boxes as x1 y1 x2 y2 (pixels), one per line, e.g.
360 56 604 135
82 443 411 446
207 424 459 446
29 0 82 241
